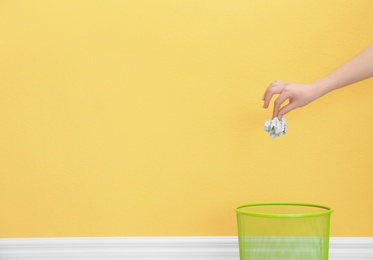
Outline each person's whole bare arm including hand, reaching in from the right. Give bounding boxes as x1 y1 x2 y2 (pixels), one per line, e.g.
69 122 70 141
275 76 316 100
262 45 373 119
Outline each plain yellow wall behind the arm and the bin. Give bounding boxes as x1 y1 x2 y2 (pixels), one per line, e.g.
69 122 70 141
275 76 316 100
0 0 373 237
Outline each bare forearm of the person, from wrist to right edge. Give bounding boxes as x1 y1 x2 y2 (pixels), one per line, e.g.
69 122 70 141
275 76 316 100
314 45 373 96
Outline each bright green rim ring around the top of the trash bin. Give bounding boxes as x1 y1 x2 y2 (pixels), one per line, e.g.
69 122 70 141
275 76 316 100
235 202 333 218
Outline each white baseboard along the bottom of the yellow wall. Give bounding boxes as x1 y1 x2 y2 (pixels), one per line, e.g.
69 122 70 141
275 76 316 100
0 237 373 260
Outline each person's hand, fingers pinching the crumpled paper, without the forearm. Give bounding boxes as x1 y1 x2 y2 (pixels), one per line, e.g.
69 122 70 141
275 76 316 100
262 80 321 119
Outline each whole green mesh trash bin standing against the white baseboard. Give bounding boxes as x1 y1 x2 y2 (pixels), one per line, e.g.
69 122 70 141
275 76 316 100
235 202 332 260
